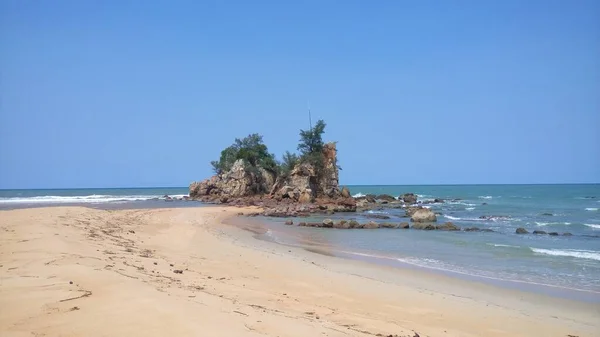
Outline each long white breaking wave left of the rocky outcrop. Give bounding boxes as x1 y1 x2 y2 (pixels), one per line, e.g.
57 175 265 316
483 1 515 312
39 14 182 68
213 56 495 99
0 194 163 204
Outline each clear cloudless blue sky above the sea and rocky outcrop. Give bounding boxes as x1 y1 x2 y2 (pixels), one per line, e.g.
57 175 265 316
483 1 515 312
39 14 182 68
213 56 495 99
0 0 600 188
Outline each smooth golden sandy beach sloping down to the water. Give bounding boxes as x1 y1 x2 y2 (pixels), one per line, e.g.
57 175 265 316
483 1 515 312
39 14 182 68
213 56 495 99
0 207 600 337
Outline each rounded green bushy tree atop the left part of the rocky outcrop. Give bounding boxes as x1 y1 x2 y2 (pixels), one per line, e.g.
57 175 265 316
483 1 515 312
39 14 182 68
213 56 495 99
211 133 277 174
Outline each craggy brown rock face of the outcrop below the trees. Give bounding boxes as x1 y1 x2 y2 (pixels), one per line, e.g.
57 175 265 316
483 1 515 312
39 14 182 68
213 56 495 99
190 143 355 208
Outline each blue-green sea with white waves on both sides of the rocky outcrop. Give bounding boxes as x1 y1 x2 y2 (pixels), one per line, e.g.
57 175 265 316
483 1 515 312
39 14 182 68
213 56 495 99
0 184 600 303
